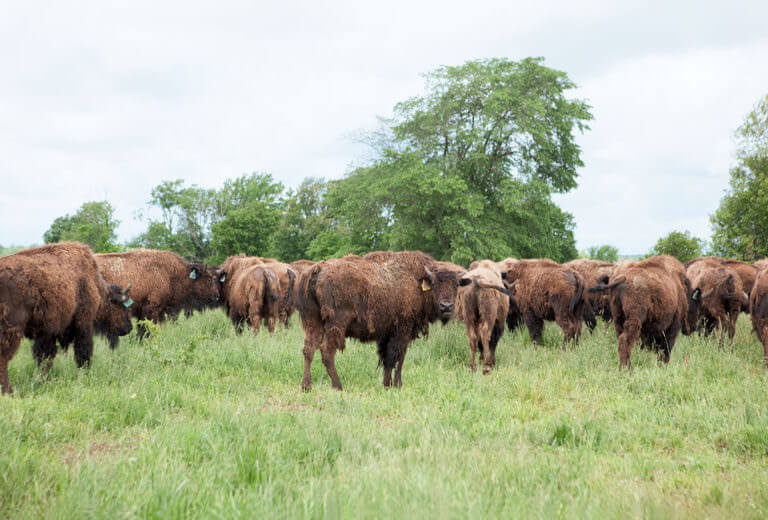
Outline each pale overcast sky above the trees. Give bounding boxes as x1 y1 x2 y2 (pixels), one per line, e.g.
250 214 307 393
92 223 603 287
0 0 768 254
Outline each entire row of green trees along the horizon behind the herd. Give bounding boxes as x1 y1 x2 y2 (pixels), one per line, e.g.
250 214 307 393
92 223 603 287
33 58 768 265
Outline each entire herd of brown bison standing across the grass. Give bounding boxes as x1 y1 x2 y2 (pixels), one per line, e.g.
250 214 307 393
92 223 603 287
0 242 768 393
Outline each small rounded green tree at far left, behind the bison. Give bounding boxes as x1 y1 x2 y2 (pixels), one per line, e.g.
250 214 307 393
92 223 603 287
43 200 120 253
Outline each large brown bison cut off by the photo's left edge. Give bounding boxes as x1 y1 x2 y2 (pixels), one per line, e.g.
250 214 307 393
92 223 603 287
0 242 131 393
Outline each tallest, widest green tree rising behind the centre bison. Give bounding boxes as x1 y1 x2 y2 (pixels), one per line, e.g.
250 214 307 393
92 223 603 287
310 58 591 263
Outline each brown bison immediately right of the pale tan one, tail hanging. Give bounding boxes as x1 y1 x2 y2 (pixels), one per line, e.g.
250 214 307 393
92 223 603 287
504 258 585 350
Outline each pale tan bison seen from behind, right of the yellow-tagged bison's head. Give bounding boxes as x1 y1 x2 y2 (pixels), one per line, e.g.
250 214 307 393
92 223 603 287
456 264 510 374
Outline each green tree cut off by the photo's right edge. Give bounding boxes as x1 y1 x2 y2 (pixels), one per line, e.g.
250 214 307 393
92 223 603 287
710 95 768 261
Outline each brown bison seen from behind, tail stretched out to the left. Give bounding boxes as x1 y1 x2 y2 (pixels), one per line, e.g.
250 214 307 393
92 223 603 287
588 255 701 368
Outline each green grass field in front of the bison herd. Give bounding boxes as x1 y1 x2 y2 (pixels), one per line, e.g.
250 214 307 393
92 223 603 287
0 311 768 519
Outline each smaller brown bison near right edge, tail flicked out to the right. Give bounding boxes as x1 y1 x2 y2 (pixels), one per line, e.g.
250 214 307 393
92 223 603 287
686 262 749 347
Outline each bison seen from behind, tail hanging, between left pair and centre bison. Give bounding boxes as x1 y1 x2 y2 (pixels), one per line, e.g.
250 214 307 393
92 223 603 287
226 265 280 334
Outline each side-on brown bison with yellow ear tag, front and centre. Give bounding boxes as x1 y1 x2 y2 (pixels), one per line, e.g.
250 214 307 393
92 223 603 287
298 252 458 390
